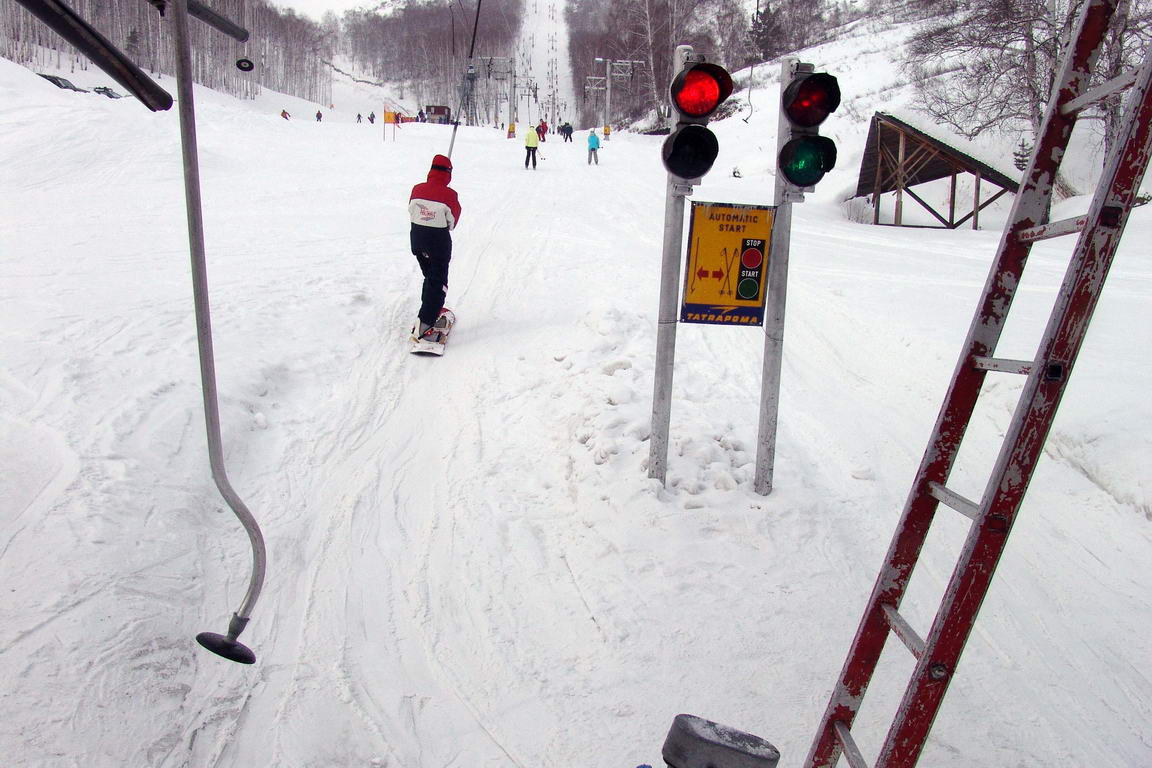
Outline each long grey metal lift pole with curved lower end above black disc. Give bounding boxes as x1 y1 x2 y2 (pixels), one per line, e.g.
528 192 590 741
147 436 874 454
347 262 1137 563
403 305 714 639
173 0 266 663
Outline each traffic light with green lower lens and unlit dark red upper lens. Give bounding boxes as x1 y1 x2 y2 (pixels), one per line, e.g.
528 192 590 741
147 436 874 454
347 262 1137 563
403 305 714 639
776 64 840 193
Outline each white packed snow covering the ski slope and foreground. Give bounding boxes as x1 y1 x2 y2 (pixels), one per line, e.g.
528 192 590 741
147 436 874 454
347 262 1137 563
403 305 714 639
0 17 1152 768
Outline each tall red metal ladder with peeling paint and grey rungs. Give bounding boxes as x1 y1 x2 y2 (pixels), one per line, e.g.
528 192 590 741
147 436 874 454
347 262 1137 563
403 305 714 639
804 0 1152 768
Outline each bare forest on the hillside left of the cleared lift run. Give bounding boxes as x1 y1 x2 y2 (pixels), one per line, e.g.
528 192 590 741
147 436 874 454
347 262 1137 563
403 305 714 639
0 0 522 111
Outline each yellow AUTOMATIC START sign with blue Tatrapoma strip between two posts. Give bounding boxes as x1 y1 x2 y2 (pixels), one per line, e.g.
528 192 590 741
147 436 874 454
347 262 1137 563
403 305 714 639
680 201 775 326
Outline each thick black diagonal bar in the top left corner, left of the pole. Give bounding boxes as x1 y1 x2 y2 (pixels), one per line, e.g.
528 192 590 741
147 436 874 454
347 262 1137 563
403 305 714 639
16 0 172 112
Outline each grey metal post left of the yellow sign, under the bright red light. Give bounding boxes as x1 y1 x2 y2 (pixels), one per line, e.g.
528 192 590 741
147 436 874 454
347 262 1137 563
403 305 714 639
649 45 692 484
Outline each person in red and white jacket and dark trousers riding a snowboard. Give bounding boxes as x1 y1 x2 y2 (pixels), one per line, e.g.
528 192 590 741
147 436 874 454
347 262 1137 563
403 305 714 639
408 154 460 339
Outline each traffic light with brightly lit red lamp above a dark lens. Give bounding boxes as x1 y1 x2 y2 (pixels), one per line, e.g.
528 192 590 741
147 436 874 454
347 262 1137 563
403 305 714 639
662 61 732 181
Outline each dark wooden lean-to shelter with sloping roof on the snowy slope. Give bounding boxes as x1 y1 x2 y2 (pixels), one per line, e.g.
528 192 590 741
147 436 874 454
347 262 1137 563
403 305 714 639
854 112 1020 229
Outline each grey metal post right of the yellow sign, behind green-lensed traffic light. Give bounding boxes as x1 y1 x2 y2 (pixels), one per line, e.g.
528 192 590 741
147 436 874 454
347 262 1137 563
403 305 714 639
752 58 797 496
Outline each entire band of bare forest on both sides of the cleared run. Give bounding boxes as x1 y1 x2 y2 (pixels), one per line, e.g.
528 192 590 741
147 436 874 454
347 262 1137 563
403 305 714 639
0 0 1152 156
